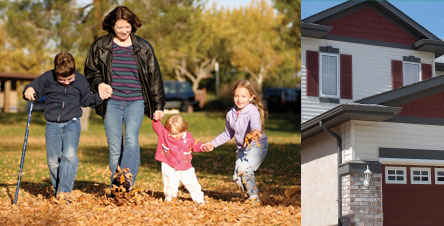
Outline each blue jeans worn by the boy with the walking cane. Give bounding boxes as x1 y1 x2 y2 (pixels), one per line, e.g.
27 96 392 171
45 118 80 193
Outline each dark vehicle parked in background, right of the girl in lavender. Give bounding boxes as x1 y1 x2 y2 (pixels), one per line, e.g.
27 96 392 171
262 87 301 113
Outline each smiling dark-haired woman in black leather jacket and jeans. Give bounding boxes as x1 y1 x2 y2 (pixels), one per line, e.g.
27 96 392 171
84 6 165 188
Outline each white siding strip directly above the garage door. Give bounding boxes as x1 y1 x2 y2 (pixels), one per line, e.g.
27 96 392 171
351 121 444 160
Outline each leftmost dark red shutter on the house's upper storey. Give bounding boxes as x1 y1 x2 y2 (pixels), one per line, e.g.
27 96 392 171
307 50 319 97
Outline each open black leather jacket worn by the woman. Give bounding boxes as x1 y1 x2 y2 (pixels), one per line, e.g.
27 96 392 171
84 33 165 119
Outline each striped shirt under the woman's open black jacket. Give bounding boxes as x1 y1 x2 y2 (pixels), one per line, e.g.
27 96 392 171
111 42 143 101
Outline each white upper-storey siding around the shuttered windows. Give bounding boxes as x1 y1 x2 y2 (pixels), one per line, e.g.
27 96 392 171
301 37 435 122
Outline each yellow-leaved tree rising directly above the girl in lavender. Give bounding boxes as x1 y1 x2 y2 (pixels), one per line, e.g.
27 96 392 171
227 0 285 91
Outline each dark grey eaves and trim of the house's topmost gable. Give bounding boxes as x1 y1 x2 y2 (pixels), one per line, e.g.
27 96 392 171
301 1 444 57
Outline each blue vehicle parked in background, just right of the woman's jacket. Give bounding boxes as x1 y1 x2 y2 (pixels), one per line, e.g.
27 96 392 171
163 81 199 112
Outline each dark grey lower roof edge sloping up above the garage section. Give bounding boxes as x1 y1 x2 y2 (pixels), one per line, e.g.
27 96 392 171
301 76 444 139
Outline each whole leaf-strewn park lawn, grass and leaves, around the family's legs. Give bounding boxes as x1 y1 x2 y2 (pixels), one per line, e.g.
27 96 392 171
0 112 300 225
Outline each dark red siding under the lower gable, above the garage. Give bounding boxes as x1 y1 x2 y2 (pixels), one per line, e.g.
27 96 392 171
398 92 444 118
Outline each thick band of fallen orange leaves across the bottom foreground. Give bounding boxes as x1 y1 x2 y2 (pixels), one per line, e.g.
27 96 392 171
0 185 301 225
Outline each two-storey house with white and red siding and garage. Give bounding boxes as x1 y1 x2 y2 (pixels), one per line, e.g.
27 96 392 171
301 1 444 226
